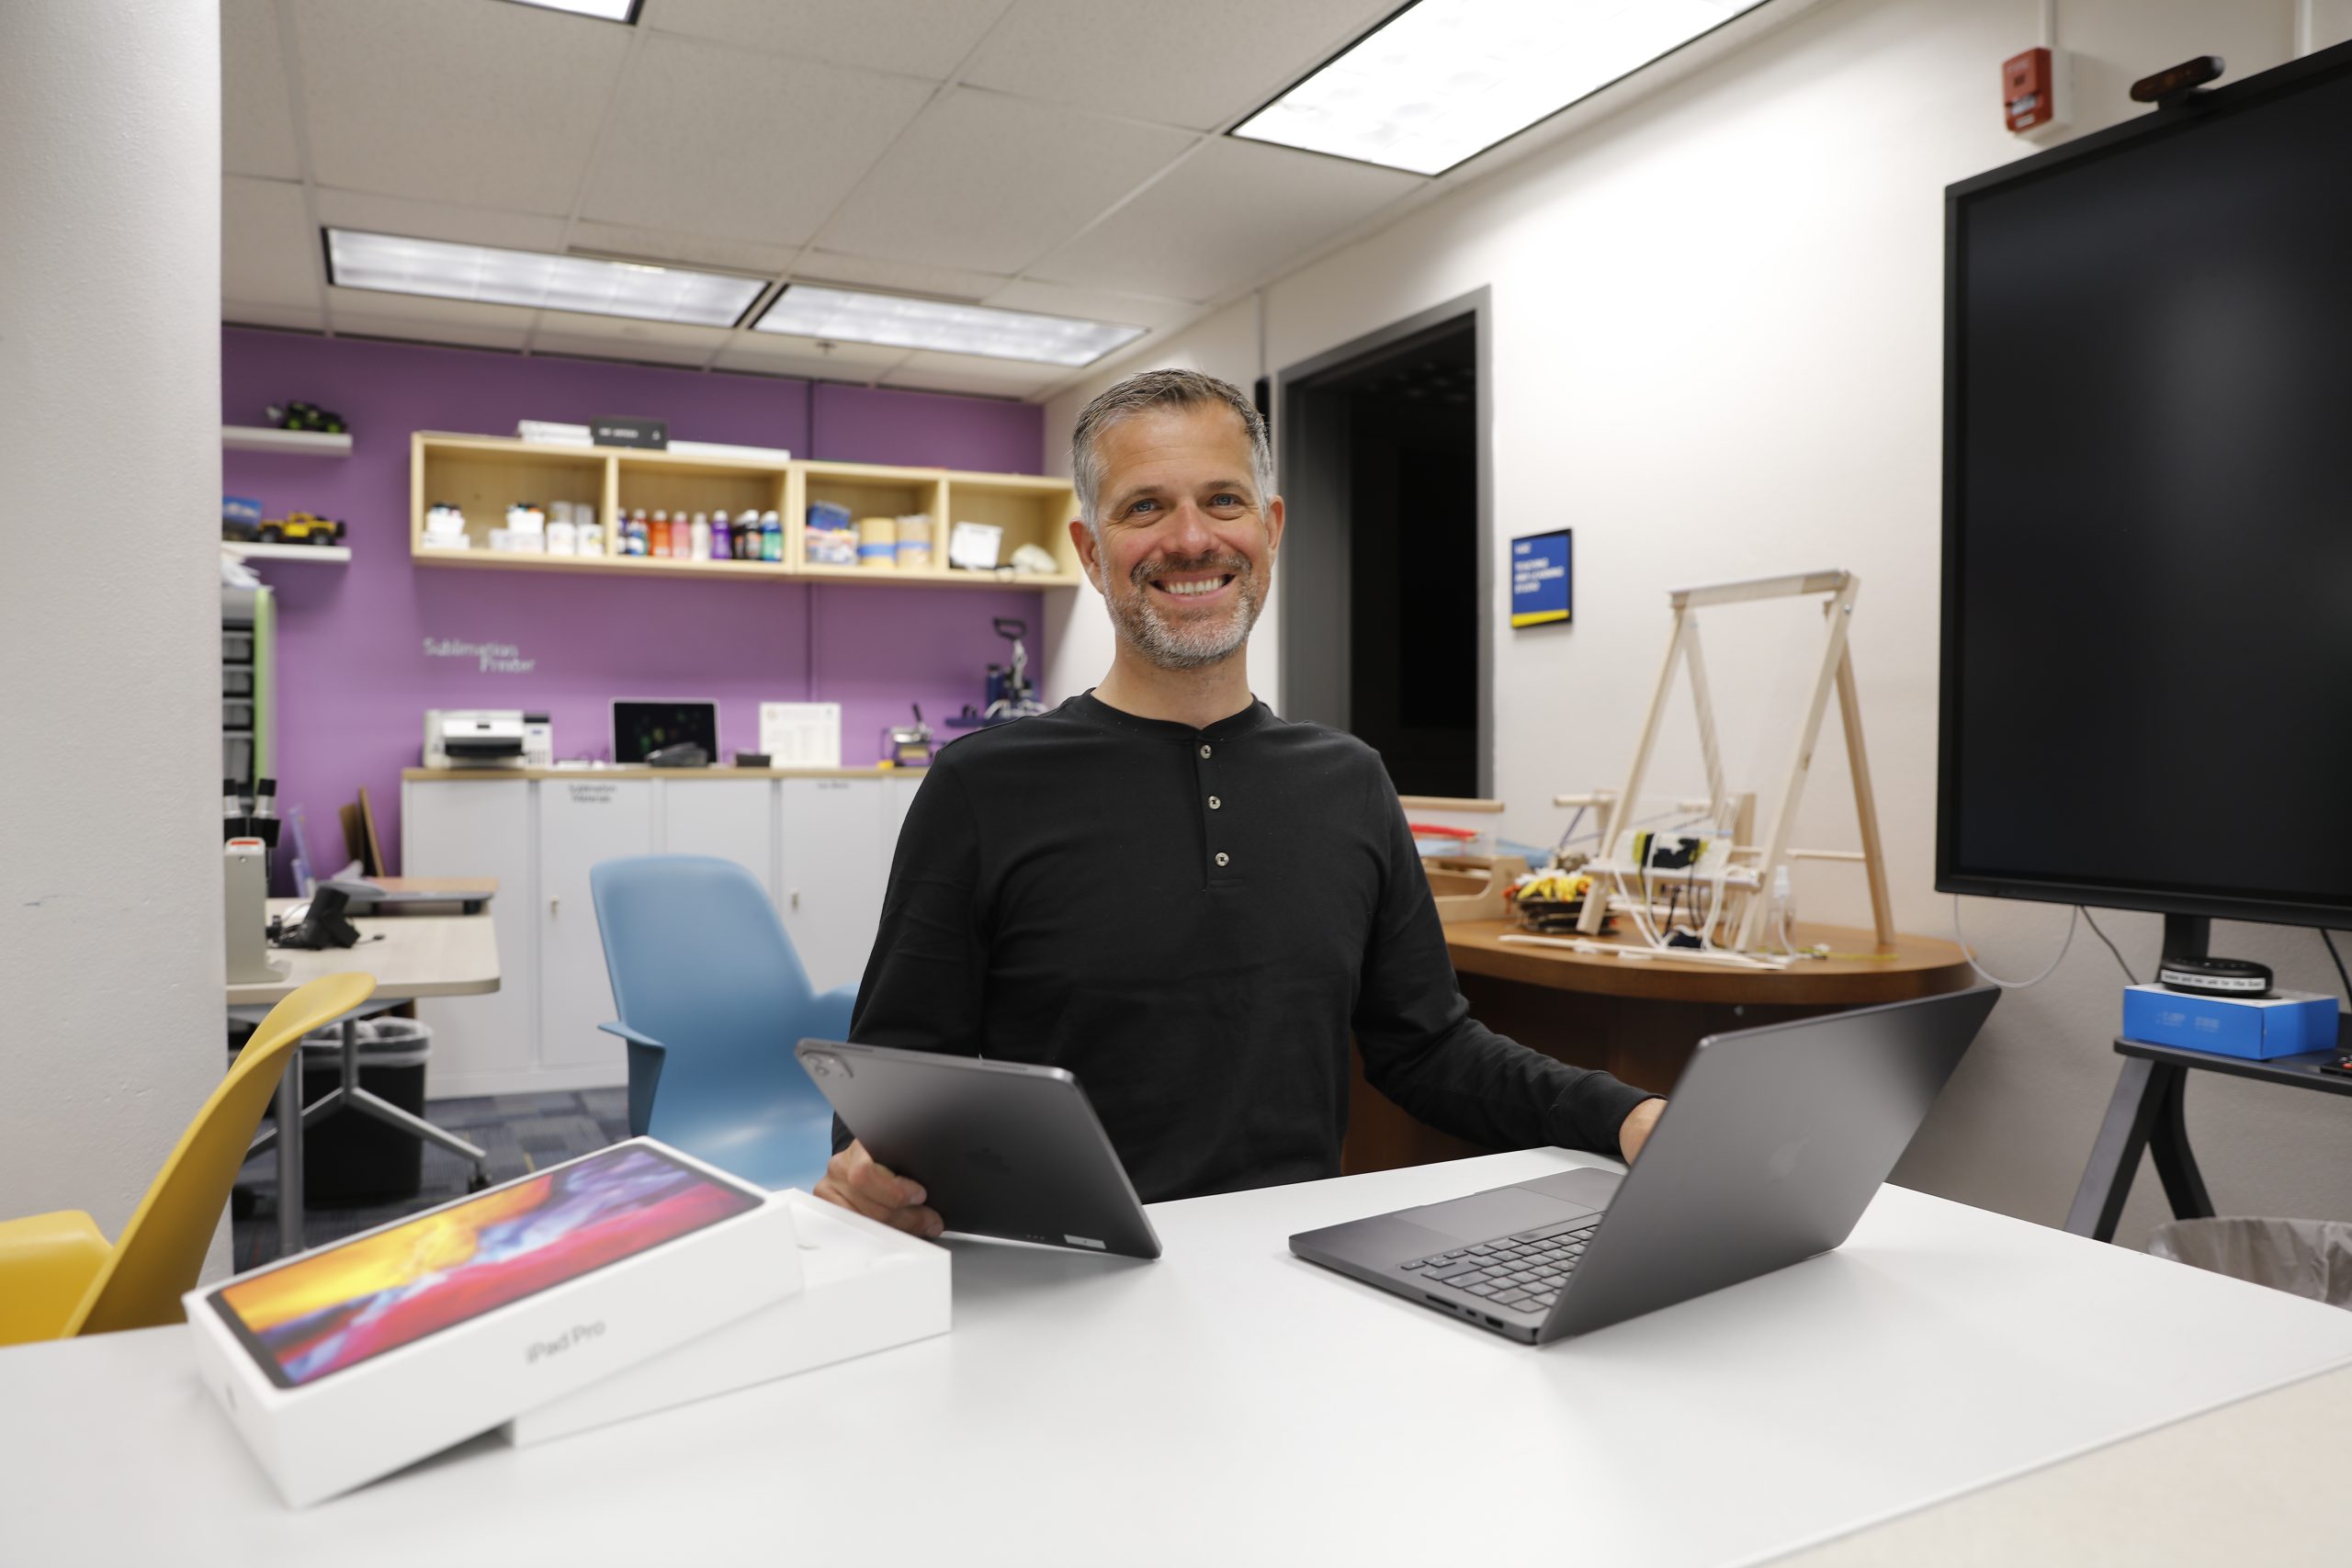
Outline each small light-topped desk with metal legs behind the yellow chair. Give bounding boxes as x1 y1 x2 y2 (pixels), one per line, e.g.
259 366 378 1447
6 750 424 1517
228 902 499 1258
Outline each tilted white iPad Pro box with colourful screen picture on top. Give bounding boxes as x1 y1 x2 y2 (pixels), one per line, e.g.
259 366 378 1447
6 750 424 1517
184 1138 802 1506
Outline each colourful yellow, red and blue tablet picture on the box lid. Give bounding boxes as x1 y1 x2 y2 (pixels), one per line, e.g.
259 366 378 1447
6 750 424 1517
209 1143 764 1389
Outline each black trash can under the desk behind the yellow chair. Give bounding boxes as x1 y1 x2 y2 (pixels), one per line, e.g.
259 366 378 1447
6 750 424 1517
301 1018 433 1208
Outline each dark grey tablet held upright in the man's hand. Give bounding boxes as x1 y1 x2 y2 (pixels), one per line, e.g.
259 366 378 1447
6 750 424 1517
797 1039 1159 1258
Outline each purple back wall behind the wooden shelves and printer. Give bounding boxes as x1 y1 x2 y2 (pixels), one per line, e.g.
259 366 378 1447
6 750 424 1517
221 329 1045 867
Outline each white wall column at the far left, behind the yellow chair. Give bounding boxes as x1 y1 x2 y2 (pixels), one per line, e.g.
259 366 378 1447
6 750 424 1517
0 0 223 1262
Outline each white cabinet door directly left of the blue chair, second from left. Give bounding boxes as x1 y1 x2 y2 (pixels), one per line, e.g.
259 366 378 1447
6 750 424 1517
531 778 654 1084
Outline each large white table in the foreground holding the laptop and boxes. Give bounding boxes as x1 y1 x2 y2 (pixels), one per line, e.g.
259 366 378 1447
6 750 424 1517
0 1149 2352 1568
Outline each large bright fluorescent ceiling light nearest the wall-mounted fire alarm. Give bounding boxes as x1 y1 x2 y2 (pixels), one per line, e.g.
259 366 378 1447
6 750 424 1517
1232 0 1764 174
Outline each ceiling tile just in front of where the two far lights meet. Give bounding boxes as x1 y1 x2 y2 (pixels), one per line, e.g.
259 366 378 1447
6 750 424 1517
581 35 933 244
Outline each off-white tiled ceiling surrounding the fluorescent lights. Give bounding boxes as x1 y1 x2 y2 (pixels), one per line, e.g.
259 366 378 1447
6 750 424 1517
221 0 1456 398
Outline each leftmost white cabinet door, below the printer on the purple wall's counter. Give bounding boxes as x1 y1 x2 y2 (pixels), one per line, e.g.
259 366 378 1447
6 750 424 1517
400 778 538 1098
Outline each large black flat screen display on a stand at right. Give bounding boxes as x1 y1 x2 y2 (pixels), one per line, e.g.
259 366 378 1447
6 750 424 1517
1936 47 2352 924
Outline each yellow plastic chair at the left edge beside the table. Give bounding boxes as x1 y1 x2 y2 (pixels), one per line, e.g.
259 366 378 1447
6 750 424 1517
0 976 377 1345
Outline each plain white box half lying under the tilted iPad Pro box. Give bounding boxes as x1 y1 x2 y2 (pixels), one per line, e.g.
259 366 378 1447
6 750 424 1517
505 1190 950 1448
